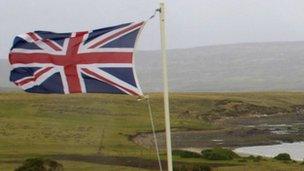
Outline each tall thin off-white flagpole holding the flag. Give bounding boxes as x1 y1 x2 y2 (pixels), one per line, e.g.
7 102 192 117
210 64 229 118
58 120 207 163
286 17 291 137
159 0 173 171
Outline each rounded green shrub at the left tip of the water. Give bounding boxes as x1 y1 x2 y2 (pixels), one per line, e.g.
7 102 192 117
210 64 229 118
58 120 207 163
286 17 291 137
202 147 239 160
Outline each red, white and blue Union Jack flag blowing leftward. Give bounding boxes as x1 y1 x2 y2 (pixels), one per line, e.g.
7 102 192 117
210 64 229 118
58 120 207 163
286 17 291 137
9 22 145 96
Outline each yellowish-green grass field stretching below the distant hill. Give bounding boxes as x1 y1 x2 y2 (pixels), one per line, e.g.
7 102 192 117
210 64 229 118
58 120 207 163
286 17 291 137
0 92 304 171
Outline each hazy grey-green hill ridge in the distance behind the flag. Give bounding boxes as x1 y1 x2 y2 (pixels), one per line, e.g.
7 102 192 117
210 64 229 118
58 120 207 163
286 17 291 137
0 42 304 92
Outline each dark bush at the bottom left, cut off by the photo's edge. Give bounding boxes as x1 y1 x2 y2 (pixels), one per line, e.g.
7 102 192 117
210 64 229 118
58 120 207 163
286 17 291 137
15 158 63 171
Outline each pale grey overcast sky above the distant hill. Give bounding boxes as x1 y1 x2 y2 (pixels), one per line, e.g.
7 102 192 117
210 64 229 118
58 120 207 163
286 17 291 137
0 0 304 58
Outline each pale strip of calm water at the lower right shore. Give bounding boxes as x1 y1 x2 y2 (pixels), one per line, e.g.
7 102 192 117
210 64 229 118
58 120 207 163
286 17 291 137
234 142 304 161
